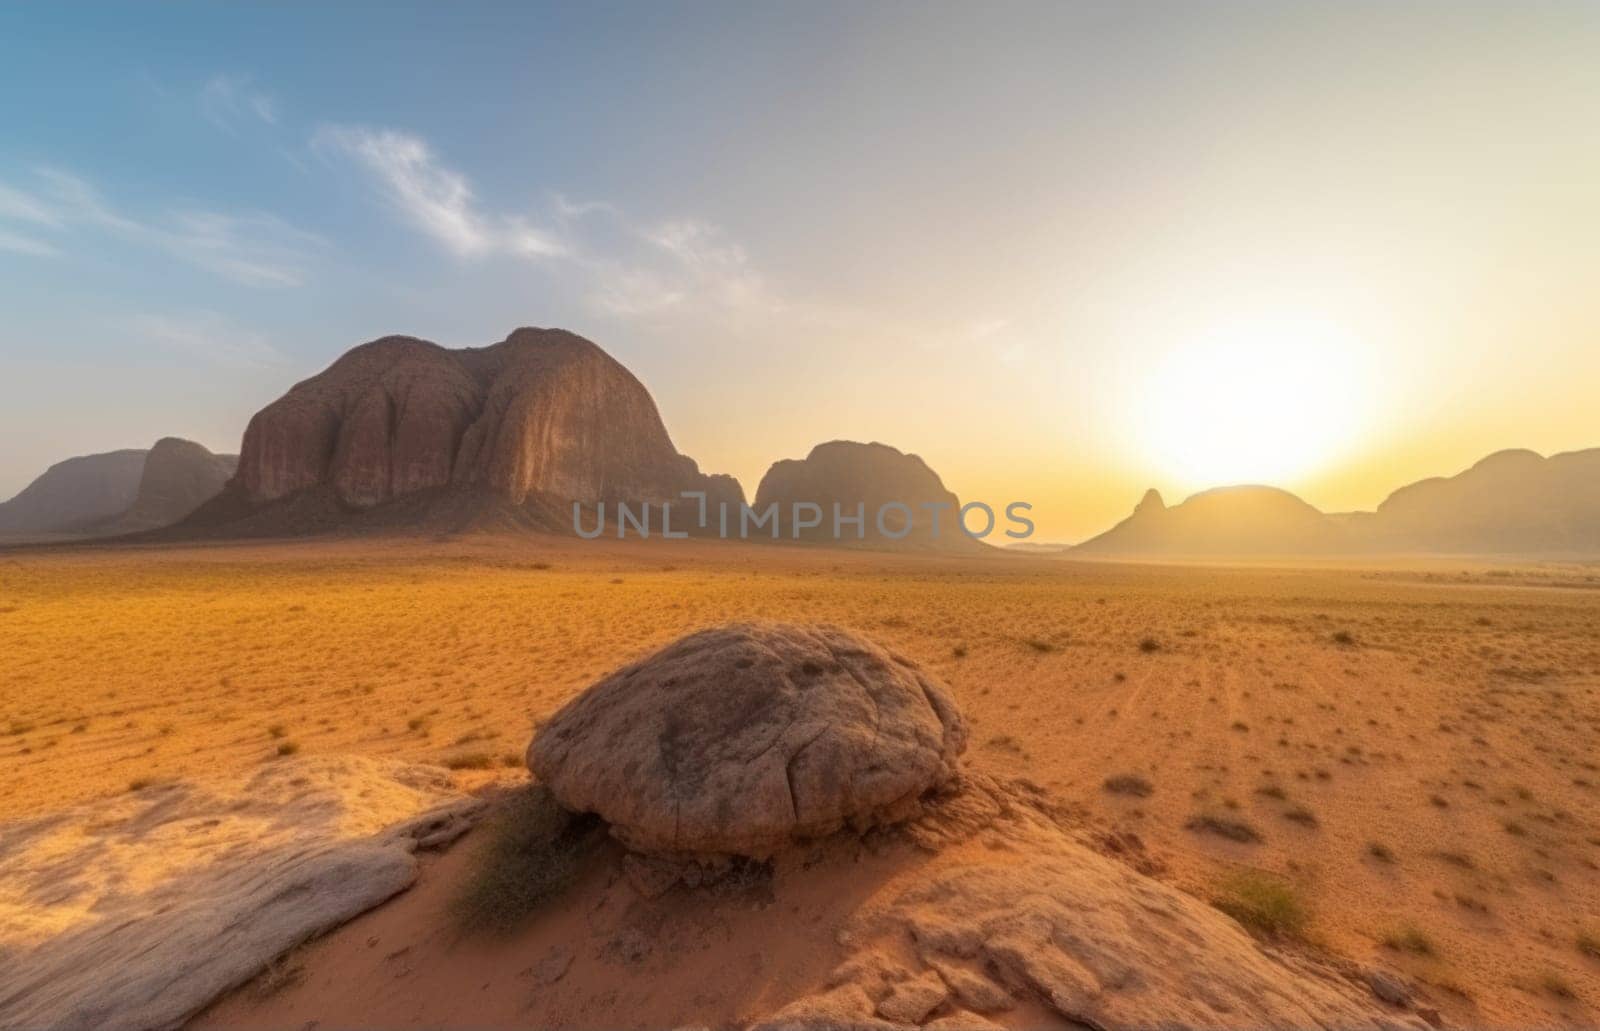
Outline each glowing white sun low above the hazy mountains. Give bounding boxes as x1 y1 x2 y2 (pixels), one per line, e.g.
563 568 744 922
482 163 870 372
1141 319 1365 488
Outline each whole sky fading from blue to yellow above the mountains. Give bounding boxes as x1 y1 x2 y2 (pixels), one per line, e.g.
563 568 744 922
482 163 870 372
0 0 1600 540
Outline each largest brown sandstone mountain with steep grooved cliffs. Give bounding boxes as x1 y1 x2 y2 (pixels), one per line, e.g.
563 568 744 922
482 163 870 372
186 328 744 533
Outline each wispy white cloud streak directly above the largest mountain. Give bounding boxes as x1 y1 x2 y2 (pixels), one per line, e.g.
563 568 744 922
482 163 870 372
312 125 778 317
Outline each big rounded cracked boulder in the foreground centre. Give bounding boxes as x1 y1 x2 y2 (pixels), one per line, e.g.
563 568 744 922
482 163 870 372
528 623 966 858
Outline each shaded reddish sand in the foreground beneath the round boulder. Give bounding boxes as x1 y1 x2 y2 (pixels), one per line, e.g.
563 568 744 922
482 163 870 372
192 806 1069 1029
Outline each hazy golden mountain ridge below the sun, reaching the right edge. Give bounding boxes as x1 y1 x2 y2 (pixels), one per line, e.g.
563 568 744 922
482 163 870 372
1072 448 1600 557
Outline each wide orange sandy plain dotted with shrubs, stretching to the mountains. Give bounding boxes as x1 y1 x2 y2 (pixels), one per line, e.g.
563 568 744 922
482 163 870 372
0 540 1600 1026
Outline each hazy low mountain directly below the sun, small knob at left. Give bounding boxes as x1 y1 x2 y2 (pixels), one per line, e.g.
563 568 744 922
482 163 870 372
1075 487 1347 556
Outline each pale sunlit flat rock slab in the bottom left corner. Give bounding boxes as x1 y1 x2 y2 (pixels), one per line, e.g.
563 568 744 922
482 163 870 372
0 756 482 1029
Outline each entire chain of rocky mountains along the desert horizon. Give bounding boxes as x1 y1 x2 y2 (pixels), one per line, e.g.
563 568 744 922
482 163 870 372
9 328 1600 557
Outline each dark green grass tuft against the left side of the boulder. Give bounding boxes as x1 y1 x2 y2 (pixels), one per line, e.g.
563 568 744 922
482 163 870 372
451 784 603 935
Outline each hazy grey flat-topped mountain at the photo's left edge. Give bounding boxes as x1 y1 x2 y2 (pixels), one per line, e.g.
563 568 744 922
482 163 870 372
0 448 147 536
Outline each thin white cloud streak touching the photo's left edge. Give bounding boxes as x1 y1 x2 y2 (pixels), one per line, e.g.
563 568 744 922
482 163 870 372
0 168 323 287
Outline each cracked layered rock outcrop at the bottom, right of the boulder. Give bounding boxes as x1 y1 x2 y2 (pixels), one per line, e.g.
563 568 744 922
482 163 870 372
758 831 1427 1031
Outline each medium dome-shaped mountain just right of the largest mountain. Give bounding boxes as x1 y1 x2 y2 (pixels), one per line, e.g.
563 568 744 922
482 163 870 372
752 440 985 552
